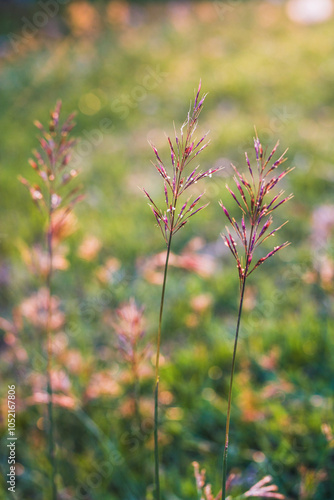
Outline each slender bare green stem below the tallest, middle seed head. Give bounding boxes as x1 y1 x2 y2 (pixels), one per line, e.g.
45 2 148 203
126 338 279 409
154 231 173 500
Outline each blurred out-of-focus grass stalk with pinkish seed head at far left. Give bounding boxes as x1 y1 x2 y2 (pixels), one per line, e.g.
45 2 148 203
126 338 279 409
19 101 82 500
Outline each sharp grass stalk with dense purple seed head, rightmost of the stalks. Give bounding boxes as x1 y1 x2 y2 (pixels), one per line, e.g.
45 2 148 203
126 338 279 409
220 135 292 500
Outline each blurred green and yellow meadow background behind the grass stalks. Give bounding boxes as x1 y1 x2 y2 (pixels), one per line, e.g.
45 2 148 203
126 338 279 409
0 0 334 500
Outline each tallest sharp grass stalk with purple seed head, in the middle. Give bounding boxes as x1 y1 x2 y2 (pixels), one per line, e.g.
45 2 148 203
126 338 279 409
143 83 220 500
